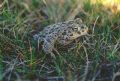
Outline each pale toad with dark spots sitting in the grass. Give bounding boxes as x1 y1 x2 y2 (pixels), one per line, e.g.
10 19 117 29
33 18 88 54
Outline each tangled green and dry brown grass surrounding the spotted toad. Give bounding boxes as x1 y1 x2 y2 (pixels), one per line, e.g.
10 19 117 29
0 0 120 81
